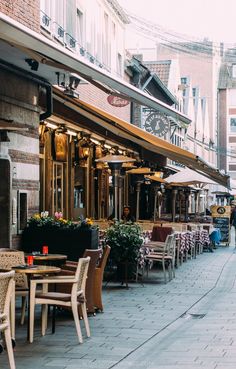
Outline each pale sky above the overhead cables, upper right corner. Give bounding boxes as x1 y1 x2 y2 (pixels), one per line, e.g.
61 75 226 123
118 0 236 46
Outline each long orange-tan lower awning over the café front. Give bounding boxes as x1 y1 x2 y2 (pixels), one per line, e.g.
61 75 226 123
54 89 229 187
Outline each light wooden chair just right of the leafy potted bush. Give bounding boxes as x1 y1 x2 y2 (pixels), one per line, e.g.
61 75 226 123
145 234 175 283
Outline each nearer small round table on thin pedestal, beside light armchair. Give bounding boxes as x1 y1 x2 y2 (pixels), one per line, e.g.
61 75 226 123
12 265 61 340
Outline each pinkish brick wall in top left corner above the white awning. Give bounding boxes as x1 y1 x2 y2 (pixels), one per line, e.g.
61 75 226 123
0 0 40 32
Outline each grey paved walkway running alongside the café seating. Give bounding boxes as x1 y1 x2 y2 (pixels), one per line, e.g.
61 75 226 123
0 238 236 369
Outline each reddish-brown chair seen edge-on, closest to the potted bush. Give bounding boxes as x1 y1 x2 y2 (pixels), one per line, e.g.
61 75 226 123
93 245 111 311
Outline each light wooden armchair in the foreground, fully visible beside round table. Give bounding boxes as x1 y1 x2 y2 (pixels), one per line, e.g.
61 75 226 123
29 256 90 343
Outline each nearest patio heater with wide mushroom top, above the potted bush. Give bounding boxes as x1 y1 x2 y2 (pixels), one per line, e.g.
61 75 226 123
96 154 136 219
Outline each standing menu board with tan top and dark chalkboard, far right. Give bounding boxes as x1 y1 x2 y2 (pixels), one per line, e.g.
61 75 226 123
211 205 231 243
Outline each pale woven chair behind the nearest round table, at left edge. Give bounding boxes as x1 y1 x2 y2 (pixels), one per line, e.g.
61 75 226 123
0 250 29 324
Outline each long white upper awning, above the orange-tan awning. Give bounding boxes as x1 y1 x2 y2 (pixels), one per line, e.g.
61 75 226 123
0 13 191 125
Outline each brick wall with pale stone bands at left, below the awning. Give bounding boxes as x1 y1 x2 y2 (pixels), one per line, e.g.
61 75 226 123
0 68 40 247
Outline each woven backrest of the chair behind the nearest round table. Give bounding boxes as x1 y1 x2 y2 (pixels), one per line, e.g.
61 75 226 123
0 251 28 288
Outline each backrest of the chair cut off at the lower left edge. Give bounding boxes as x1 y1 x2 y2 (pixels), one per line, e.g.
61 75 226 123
0 271 15 314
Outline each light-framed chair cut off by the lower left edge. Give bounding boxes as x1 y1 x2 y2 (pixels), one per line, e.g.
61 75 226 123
0 271 15 369
